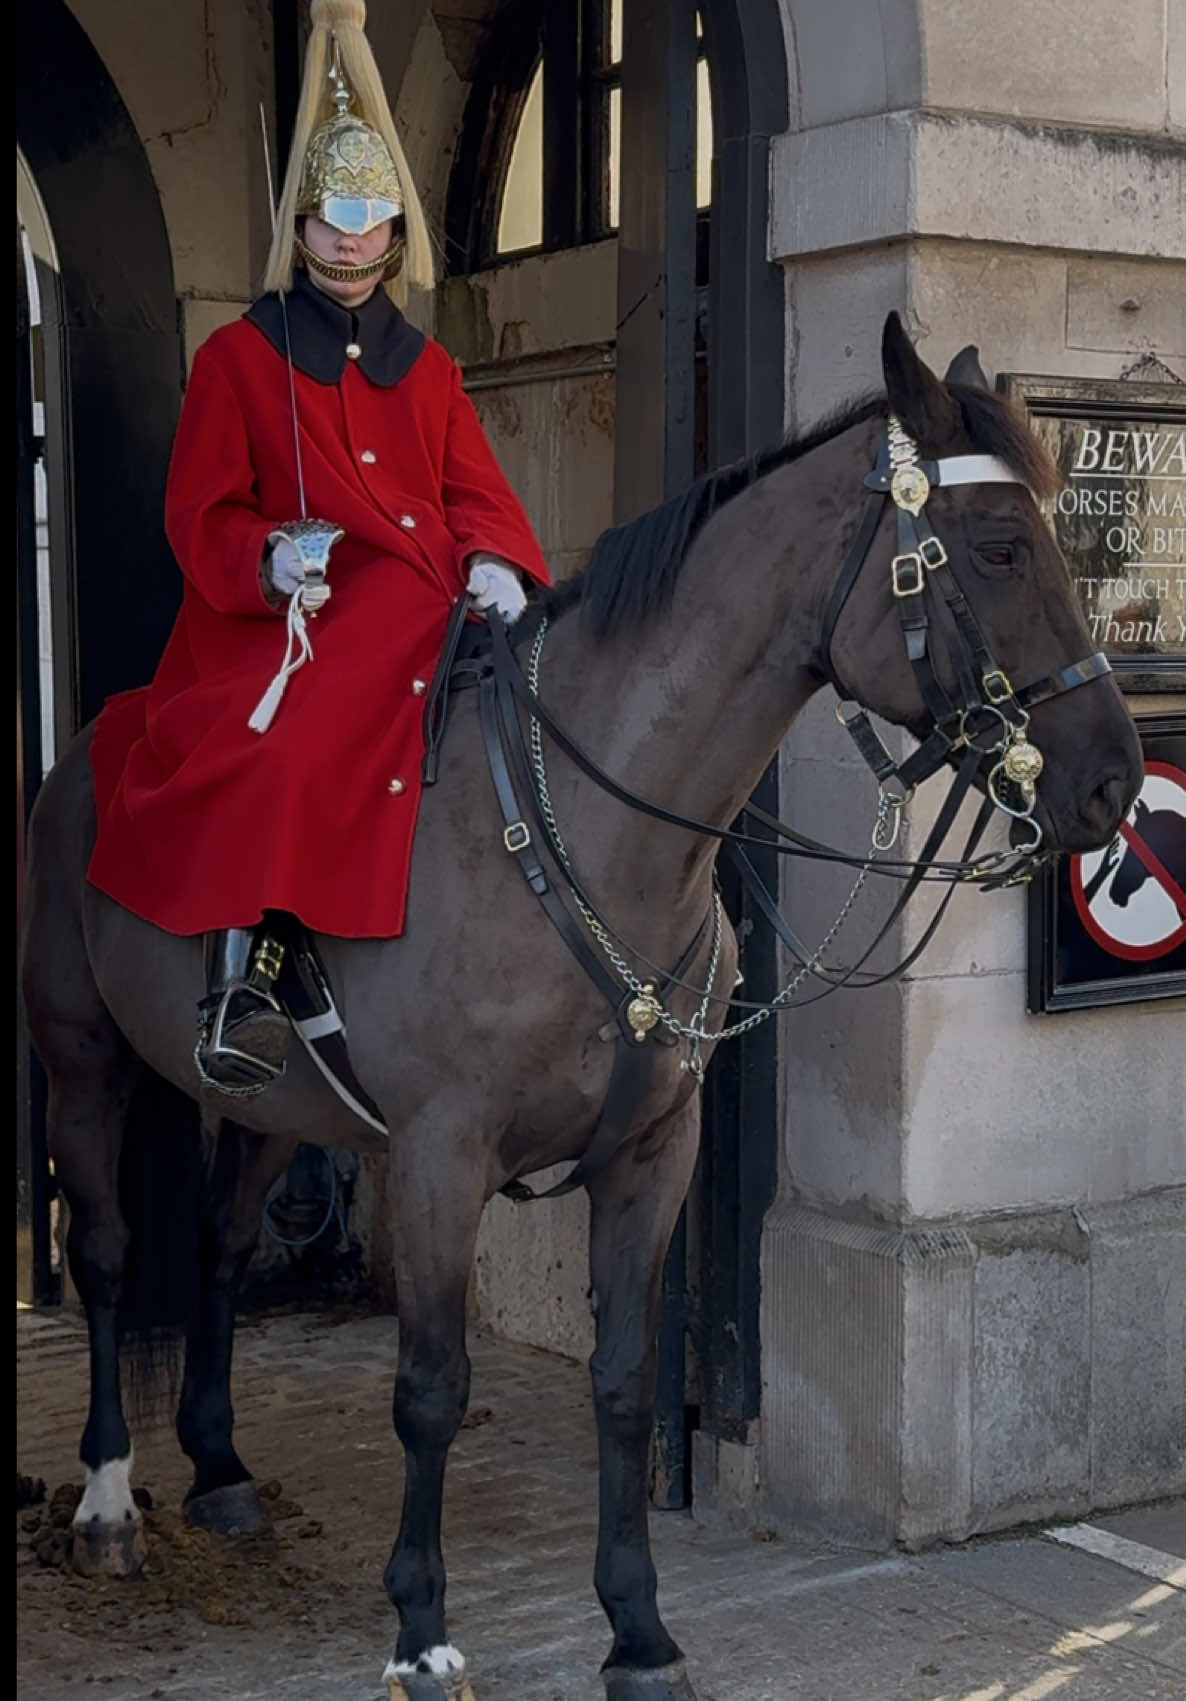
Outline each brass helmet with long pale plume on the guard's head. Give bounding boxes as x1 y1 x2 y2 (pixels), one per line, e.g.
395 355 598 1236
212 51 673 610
264 0 434 299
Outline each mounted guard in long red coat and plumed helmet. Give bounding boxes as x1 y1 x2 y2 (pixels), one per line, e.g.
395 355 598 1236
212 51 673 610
88 0 550 1095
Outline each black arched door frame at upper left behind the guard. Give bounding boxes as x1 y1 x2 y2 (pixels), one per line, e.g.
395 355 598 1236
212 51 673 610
17 0 182 721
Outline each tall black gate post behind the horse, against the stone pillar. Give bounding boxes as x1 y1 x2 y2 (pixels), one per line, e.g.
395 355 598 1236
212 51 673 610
614 0 788 1507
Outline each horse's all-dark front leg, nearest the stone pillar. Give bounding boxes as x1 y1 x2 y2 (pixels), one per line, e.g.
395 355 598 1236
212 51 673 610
589 1094 699 1701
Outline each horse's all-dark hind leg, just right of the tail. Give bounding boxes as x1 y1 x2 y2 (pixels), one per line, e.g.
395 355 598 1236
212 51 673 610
177 1123 296 1536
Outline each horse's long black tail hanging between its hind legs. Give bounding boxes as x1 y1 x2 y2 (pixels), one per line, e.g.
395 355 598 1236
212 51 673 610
119 1067 204 1417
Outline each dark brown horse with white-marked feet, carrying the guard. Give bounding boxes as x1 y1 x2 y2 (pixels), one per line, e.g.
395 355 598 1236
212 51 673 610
24 315 1142 1701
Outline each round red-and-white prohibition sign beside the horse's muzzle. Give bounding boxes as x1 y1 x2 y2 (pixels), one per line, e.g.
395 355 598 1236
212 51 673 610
1070 762 1186 963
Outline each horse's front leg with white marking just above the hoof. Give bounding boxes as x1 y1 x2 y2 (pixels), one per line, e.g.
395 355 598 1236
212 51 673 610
383 1116 485 1701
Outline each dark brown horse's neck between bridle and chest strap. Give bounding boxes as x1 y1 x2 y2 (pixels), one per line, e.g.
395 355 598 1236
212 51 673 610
530 424 876 938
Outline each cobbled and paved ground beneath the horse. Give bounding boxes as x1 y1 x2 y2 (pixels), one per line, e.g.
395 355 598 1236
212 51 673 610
17 1313 1186 1701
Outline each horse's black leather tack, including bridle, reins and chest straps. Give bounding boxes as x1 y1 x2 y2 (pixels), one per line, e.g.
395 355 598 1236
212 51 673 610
424 415 1109 1201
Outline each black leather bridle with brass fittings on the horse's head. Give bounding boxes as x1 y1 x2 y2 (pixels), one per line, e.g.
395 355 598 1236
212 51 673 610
822 413 1111 862
